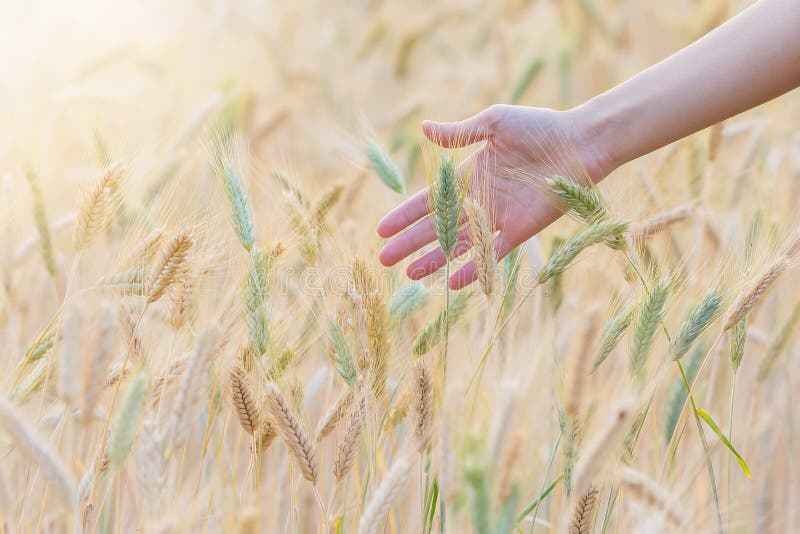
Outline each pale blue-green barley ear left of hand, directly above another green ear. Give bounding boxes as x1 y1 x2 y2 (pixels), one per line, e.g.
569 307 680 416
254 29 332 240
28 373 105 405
212 139 255 251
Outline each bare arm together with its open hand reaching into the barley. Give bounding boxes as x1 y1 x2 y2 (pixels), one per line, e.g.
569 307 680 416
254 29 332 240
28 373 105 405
377 0 800 289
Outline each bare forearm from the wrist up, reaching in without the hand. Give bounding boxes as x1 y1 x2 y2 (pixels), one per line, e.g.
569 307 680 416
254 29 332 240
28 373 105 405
571 0 800 174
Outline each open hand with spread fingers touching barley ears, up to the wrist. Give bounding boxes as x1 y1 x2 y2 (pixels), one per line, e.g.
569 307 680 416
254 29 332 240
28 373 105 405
378 105 613 289
